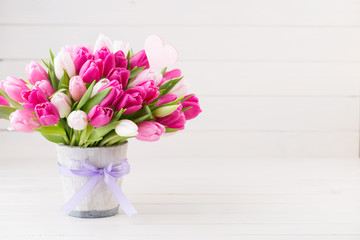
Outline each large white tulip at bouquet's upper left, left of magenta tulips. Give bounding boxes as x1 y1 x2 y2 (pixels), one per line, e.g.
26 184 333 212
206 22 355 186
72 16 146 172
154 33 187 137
54 51 76 80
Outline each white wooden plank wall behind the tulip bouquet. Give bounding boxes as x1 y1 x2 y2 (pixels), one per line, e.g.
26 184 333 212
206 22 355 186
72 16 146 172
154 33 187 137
0 0 360 157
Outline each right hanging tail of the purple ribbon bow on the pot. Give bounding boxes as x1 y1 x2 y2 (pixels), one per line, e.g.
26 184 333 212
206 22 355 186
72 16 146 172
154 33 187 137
104 176 137 217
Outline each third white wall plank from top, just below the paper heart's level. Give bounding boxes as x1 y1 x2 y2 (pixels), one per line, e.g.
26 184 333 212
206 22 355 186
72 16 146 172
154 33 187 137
0 59 360 96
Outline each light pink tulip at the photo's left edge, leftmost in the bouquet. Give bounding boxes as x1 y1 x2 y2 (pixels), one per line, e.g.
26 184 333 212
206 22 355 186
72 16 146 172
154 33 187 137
0 77 29 103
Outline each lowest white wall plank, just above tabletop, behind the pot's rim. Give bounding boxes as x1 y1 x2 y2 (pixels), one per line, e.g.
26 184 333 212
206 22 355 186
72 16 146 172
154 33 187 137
0 130 359 159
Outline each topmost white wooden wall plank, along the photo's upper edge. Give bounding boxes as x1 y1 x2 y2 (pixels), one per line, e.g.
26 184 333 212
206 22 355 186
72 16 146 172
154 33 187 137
0 0 360 26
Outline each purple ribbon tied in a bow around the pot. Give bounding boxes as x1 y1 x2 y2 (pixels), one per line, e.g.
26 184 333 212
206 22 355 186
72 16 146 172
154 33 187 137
58 159 137 217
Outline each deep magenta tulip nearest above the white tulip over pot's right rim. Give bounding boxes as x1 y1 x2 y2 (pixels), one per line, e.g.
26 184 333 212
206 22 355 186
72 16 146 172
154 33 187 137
116 87 146 114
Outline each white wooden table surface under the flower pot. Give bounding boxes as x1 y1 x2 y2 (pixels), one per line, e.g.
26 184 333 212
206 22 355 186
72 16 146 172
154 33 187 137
0 156 360 240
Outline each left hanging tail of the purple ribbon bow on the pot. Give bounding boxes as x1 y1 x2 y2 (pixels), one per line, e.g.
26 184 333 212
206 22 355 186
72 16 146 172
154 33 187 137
61 175 101 215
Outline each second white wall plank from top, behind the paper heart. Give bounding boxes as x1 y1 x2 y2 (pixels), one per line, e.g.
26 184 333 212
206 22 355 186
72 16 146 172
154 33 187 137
0 25 360 61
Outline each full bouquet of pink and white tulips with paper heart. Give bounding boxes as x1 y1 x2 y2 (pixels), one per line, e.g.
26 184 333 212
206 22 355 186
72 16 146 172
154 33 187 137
0 35 201 147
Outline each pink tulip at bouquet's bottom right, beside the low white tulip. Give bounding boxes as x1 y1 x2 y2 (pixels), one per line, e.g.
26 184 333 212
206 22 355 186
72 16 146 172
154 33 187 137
136 121 165 142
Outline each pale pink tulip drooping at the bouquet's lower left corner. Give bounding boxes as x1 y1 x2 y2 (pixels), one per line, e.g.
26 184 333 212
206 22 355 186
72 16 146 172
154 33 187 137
9 110 41 133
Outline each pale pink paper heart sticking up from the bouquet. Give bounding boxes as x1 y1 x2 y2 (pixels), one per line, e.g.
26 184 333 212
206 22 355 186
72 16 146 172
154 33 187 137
145 35 178 69
